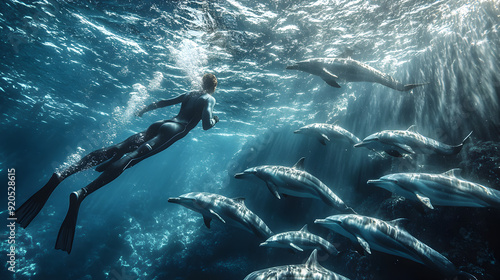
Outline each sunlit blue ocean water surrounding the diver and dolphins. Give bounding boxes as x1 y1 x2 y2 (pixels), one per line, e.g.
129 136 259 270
0 0 500 280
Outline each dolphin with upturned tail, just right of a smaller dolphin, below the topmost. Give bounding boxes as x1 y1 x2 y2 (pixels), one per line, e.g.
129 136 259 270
354 125 472 157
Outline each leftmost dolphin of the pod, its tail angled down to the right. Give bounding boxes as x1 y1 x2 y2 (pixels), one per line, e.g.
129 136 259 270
168 192 273 240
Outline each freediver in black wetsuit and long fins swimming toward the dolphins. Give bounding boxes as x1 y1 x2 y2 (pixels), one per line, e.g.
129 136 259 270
15 74 219 254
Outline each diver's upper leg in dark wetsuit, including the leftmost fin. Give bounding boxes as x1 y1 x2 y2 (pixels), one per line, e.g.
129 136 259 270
15 132 145 228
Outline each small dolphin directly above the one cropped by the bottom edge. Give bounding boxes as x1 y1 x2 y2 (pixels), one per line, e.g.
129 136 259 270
260 225 338 256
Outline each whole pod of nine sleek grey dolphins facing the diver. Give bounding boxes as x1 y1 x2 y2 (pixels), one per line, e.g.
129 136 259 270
168 58 500 280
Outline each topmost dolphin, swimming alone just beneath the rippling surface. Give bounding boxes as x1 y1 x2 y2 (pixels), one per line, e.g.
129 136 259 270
286 58 427 91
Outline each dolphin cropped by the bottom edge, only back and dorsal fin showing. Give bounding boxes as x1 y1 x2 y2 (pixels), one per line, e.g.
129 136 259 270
243 249 349 280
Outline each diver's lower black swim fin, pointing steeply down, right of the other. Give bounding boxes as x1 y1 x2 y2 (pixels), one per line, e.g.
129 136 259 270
55 191 83 254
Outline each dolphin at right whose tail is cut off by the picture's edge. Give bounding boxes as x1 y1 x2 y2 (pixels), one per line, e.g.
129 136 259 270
368 169 500 209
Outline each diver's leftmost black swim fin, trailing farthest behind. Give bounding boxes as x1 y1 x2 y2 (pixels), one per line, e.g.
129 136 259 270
14 173 62 228
